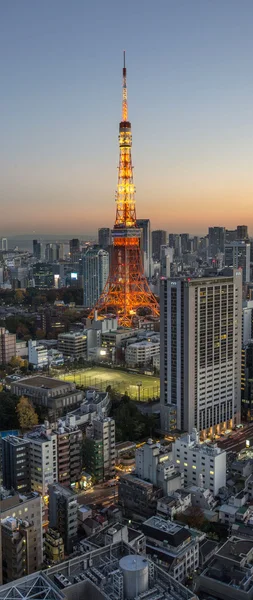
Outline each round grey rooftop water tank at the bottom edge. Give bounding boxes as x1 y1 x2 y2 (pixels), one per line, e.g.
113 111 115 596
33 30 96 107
119 554 148 600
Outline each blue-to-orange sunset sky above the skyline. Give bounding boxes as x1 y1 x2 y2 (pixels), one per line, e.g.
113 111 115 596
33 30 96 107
0 0 253 235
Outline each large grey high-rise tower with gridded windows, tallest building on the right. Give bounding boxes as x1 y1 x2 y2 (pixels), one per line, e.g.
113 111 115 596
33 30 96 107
160 270 242 437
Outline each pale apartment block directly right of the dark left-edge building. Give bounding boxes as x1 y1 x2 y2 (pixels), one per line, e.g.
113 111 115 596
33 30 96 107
25 425 58 497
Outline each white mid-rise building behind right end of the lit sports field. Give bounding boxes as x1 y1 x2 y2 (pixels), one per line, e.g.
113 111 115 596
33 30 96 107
125 336 160 368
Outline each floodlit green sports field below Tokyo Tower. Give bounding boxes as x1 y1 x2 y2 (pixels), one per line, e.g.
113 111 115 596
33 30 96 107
61 367 160 401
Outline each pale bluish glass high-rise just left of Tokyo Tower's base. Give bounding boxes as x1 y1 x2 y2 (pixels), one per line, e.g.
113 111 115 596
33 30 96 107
82 246 109 308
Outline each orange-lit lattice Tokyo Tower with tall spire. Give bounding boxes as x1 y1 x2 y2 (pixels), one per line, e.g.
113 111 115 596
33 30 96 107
89 52 160 327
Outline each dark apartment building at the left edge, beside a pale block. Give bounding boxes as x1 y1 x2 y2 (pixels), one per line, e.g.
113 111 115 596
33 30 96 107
2 435 31 494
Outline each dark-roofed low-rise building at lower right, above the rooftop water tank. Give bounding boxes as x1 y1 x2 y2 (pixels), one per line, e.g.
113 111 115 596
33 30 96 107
142 516 205 583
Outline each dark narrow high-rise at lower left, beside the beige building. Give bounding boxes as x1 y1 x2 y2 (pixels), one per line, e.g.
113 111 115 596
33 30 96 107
49 483 78 554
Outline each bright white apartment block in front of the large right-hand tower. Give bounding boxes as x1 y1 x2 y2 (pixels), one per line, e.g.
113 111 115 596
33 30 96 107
172 429 227 496
